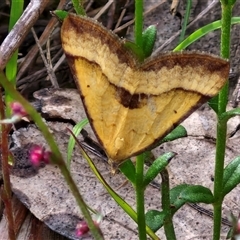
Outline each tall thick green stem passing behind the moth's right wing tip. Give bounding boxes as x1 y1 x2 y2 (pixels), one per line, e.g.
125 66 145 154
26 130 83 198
213 1 233 240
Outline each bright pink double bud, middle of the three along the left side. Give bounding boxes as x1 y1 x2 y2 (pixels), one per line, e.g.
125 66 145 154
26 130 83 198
30 145 51 167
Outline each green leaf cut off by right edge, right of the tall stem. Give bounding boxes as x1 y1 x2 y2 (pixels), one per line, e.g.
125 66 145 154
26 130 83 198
223 157 240 197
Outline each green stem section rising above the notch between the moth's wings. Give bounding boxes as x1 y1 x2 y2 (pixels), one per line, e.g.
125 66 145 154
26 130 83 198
134 0 143 49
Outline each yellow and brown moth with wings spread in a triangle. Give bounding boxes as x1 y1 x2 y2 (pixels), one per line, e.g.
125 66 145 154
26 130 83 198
61 14 229 166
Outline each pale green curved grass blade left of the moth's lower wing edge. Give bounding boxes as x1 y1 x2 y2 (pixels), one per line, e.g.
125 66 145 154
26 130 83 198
67 118 89 169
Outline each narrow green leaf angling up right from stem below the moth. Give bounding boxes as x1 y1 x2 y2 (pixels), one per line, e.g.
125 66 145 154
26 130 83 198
143 152 176 187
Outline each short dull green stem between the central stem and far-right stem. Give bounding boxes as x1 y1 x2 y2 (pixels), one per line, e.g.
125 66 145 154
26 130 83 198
160 168 176 240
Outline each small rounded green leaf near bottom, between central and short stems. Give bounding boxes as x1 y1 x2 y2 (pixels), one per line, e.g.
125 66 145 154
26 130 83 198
145 210 166 232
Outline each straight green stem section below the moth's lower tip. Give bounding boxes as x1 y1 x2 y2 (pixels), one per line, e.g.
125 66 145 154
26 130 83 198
136 154 147 240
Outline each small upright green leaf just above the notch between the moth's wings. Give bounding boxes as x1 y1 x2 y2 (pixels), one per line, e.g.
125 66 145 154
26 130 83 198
142 25 157 58
